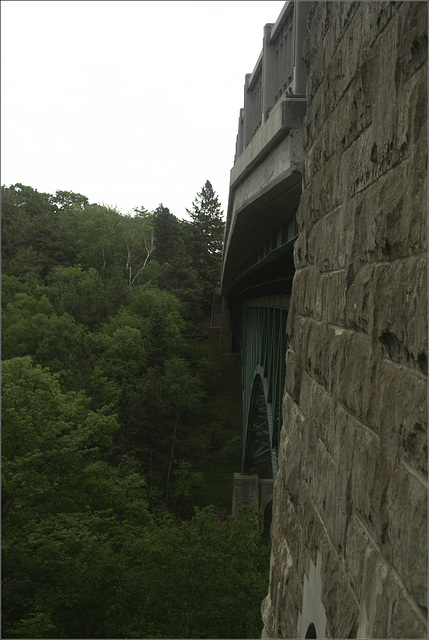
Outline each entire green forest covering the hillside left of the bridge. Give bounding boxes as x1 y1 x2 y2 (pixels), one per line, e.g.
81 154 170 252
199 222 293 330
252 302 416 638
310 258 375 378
2 181 270 638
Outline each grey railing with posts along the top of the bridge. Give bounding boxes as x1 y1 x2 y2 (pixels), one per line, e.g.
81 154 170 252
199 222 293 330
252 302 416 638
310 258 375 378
234 0 308 162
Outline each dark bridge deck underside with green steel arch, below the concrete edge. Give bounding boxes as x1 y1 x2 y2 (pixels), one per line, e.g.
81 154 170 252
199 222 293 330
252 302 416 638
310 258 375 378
223 175 301 479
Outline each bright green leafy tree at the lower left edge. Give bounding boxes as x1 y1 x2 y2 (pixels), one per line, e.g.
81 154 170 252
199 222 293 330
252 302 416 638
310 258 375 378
2 357 149 637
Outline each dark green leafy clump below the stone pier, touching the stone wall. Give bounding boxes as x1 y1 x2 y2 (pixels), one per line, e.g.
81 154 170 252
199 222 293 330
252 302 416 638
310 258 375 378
136 507 268 638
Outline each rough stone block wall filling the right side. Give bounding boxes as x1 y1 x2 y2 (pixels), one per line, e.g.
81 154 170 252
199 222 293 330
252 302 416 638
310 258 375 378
262 2 428 638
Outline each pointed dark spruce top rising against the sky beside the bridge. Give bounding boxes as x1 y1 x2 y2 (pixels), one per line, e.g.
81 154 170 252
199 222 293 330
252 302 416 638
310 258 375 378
186 180 224 256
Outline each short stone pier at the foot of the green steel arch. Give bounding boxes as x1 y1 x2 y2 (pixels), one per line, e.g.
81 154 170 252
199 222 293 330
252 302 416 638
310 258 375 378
232 473 274 531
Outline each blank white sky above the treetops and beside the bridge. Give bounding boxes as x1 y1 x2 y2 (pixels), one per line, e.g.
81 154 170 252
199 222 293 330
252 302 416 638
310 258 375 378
1 0 284 218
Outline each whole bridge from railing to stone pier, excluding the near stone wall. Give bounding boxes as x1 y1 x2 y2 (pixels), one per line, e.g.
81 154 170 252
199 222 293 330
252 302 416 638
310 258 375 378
221 2 308 524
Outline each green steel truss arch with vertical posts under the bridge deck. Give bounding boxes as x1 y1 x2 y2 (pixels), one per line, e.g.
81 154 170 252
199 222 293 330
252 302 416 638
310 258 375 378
241 296 289 478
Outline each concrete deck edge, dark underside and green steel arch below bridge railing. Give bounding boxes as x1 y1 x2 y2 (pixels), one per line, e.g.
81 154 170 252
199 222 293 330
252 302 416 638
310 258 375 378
222 81 306 479
